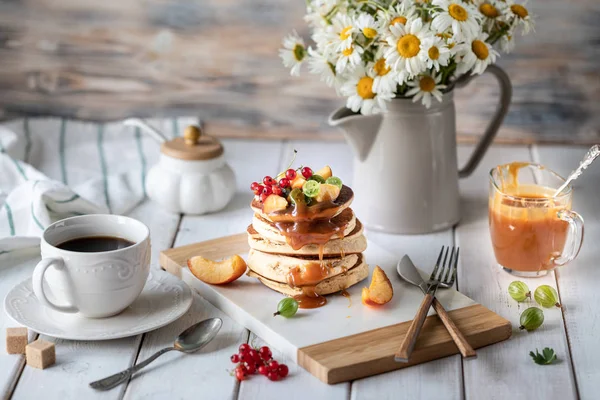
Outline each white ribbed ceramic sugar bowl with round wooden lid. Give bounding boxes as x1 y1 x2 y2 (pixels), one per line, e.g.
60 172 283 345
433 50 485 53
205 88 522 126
134 120 236 214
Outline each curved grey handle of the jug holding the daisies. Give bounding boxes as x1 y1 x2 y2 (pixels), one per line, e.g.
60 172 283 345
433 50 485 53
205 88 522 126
456 64 512 178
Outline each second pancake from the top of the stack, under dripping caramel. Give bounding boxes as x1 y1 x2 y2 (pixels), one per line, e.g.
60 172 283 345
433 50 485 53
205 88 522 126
252 208 356 243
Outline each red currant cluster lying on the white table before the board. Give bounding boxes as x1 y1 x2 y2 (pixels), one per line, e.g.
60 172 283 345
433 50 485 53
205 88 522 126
231 343 289 381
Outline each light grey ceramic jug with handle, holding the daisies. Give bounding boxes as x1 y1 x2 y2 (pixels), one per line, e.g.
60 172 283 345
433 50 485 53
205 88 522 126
329 65 512 234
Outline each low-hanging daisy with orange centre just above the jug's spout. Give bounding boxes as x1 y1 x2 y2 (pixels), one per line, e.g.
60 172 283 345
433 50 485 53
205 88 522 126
341 67 394 115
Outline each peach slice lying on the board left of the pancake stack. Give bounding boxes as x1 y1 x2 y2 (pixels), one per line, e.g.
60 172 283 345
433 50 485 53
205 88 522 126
188 255 246 285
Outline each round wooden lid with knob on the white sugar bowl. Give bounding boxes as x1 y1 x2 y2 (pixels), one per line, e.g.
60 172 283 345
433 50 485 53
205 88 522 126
160 125 223 161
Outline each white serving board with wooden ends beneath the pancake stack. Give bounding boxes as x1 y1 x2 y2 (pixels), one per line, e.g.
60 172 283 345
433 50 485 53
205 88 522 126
160 233 512 384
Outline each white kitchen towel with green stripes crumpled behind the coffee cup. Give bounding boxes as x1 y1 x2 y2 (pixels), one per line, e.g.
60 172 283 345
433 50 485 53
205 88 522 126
0 118 166 257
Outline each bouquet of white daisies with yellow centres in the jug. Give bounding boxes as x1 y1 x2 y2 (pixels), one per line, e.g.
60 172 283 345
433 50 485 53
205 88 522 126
280 0 533 115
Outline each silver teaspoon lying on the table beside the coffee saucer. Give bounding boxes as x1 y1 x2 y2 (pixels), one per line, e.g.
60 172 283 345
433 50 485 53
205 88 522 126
90 318 223 390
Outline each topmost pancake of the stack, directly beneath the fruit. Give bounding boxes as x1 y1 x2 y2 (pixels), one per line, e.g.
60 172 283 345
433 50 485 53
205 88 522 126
250 185 354 222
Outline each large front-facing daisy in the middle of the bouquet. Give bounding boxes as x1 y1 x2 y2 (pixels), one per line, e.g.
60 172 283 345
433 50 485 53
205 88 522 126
385 18 431 83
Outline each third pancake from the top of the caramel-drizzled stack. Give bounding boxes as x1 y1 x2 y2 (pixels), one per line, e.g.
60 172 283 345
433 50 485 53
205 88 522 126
246 219 367 257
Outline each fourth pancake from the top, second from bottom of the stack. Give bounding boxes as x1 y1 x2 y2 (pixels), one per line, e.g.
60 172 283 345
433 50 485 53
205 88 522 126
246 250 362 286
